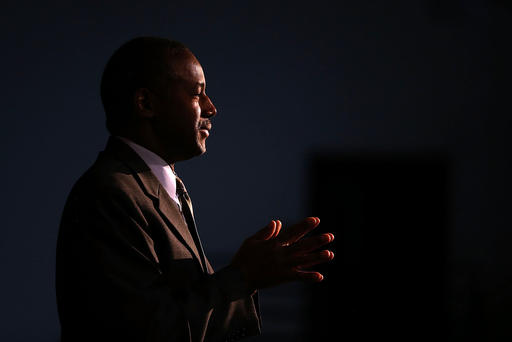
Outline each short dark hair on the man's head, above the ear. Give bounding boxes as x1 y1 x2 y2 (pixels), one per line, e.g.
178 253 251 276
100 37 189 135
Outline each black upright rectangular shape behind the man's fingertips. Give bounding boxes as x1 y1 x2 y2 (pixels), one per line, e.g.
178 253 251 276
310 154 450 341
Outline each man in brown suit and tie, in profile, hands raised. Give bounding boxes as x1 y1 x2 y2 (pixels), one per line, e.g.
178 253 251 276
56 37 334 342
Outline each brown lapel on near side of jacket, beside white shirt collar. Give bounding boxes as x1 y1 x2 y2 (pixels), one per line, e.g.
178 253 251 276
104 136 204 269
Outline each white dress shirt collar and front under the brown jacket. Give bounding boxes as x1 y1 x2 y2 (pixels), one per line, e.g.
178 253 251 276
118 136 181 210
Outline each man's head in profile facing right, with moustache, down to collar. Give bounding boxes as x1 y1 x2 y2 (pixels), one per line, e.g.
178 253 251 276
101 37 217 163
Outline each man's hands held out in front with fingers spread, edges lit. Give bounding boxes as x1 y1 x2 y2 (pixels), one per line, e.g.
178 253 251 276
232 217 334 289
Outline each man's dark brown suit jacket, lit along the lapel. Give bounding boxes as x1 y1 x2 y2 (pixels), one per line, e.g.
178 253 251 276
56 137 260 342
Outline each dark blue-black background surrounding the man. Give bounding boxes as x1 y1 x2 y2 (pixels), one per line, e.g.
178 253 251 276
0 0 512 342
